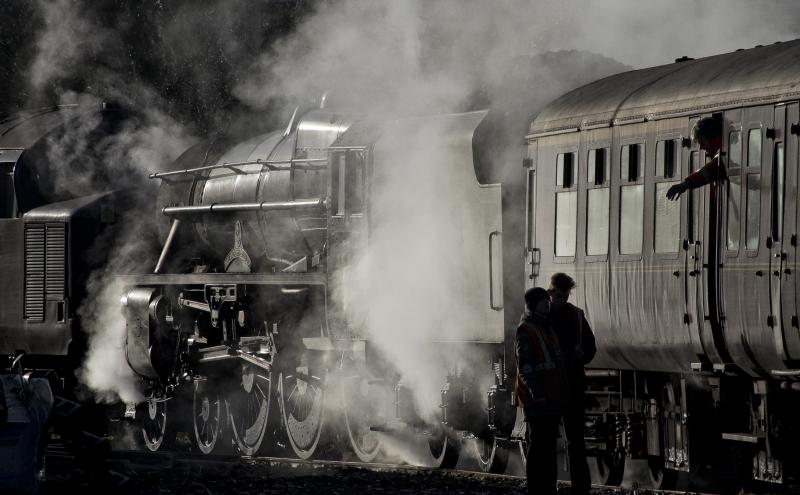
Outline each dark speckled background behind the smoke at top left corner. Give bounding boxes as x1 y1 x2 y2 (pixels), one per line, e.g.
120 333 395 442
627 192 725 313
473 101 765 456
0 0 316 134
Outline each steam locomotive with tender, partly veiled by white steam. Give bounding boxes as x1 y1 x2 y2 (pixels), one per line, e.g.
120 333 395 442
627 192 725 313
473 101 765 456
123 109 521 465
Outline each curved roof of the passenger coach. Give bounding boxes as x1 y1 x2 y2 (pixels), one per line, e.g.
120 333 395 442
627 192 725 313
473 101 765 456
528 40 800 138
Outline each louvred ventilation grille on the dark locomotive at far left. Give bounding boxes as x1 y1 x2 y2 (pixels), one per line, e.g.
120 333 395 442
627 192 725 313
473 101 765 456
25 223 67 321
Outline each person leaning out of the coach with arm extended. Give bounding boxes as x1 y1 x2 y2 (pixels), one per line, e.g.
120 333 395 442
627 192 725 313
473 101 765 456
667 117 725 201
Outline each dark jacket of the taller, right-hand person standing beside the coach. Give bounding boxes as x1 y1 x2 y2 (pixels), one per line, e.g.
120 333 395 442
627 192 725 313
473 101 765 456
550 303 597 376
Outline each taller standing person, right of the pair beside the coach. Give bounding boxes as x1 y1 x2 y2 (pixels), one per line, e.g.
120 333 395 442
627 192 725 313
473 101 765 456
548 273 597 495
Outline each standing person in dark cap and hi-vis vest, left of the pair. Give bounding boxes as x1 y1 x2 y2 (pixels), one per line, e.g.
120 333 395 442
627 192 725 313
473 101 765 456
514 287 567 495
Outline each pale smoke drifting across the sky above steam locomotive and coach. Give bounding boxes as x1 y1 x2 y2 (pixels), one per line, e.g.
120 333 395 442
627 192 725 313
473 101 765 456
235 0 800 114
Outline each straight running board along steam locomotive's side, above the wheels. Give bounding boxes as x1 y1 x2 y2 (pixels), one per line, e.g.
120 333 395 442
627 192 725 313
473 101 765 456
119 272 326 286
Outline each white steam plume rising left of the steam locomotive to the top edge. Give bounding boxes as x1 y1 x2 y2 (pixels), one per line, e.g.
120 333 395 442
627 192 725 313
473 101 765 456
29 0 194 402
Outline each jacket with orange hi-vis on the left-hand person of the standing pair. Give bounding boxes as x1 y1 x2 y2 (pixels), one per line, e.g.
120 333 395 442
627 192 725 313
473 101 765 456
514 316 569 418
